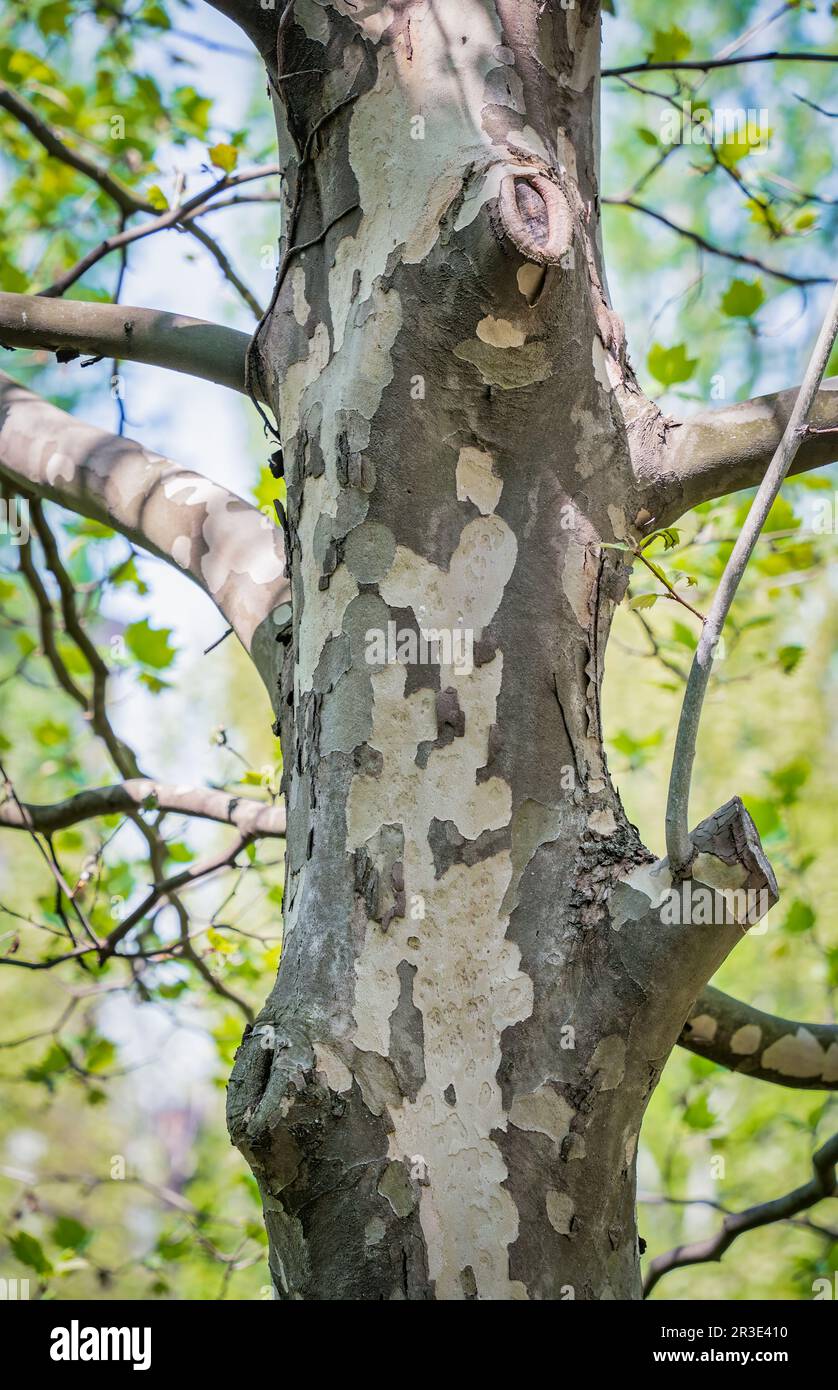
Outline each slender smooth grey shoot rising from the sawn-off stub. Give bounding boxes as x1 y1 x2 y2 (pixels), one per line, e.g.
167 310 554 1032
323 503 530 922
666 284 838 874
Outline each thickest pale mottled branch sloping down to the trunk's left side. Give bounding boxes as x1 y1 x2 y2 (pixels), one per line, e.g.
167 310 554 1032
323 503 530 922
0 373 290 653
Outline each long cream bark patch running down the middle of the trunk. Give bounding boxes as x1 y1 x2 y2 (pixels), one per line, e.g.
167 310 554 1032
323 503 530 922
346 494 532 1300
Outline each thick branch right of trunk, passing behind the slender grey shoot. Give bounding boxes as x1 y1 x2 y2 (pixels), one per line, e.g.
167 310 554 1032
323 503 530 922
638 377 838 525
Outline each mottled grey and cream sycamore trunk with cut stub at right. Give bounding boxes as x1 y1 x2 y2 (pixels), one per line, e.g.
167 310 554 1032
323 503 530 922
229 0 773 1300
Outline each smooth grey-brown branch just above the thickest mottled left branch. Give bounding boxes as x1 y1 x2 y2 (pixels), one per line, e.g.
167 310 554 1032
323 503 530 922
0 293 255 391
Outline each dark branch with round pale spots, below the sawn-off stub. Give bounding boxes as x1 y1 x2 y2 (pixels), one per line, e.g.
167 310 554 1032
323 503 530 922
678 986 838 1091
